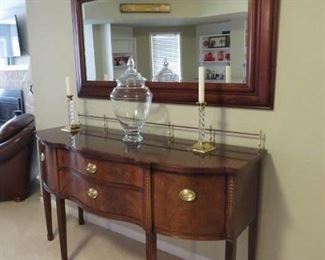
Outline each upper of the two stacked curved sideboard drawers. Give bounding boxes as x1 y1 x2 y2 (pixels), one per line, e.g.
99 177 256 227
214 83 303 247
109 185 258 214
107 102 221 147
58 150 144 188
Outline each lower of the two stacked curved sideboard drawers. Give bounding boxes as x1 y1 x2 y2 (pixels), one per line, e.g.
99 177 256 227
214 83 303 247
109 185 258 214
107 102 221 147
59 170 143 223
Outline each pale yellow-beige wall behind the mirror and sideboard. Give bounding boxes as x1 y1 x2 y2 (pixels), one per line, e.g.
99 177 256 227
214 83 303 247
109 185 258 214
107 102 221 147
26 0 325 260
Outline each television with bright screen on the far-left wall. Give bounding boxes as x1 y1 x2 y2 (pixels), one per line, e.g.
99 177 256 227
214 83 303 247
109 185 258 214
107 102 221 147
0 15 21 58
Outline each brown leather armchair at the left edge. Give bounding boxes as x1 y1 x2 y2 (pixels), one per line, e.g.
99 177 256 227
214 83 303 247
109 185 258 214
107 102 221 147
0 114 36 201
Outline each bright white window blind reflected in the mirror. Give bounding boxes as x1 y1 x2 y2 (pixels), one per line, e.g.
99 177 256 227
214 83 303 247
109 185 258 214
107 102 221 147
151 33 182 79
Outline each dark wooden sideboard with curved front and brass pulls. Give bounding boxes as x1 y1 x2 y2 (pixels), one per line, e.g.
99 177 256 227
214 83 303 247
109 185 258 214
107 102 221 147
37 126 262 260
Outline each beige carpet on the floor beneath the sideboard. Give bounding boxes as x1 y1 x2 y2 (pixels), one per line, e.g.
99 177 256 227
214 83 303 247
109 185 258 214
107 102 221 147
0 187 179 260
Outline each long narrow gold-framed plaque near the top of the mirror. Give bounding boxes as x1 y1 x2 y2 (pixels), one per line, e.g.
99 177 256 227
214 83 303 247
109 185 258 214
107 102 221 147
120 3 171 13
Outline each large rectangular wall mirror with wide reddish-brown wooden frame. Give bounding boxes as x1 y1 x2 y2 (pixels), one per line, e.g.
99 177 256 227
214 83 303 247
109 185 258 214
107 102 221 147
72 0 278 109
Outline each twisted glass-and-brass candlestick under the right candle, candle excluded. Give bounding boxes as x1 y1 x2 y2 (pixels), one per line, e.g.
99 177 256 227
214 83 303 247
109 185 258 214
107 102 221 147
191 102 216 154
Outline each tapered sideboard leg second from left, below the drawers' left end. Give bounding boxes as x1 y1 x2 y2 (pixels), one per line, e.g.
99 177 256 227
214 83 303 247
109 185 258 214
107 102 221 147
56 198 68 260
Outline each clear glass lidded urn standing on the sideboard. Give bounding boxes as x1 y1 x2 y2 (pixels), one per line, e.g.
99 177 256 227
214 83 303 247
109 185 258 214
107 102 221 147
110 58 152 143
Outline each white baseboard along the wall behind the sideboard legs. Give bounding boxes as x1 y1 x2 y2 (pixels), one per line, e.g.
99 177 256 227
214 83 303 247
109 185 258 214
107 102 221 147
41 198 210 260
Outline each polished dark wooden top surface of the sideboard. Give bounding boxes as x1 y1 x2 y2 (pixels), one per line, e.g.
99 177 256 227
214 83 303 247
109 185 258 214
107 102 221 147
37 126 262 174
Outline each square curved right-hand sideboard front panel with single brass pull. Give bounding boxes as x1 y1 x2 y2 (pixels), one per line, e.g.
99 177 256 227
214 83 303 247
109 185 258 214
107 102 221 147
153 172 226 239
